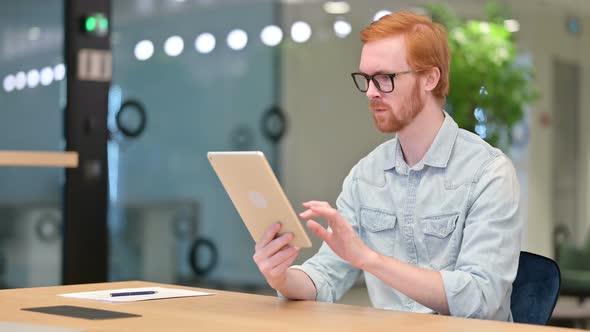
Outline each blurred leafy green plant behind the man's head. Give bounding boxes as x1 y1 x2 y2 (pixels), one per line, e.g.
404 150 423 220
427 2 537 151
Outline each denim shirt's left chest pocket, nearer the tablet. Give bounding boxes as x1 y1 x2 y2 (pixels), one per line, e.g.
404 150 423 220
360 207 397 256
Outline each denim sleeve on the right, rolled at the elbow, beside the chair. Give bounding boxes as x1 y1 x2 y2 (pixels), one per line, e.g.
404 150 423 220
441 155 523 321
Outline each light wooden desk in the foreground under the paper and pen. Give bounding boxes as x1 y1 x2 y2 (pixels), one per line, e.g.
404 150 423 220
0 281 573 332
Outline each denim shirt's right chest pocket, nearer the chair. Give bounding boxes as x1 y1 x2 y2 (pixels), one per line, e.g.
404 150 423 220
421 212 460 270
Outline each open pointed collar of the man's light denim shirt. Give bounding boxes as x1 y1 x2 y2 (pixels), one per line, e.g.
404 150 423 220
384 111 459 170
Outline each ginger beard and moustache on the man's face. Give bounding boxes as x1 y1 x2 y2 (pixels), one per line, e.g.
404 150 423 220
369 80 425 133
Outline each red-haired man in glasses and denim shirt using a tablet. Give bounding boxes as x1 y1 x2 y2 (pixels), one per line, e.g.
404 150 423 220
254 12 523 321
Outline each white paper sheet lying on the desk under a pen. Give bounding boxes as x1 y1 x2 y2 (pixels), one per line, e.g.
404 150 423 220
59 287 214 302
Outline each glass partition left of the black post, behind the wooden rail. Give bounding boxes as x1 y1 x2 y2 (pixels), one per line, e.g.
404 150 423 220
0 0 66 288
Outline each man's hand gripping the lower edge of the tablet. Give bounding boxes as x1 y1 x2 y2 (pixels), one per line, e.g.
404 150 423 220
252 223 300 290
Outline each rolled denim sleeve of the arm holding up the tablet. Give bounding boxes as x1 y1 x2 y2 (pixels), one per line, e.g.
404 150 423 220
291 167 362 302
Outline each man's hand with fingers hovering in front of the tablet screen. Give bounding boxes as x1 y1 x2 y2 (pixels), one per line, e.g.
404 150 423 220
299 201 377 269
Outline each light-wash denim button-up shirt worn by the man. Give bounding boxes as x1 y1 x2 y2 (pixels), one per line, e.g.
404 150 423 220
291 112 523 321
